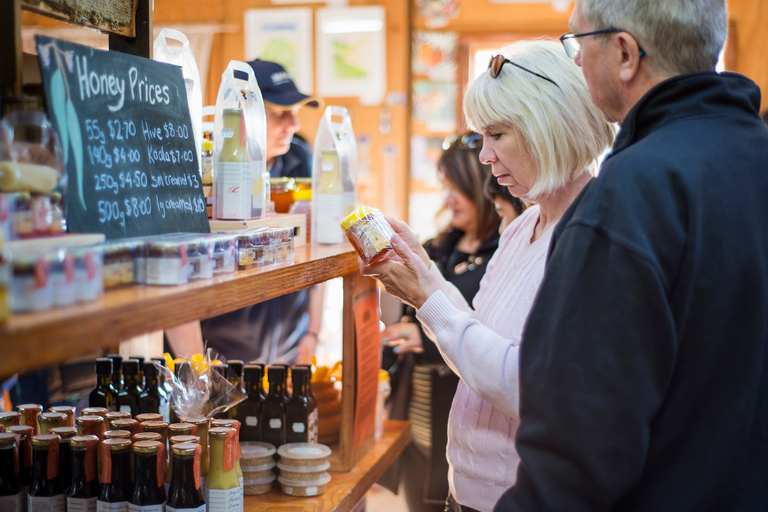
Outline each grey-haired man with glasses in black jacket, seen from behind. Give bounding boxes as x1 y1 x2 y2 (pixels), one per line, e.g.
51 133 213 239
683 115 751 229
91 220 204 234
496 0 768 512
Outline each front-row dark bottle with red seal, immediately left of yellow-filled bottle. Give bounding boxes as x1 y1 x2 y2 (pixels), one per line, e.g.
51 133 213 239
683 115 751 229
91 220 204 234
165 443 206 512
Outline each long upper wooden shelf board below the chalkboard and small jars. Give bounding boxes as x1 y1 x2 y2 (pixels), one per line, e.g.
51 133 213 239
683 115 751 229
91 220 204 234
0 244 358 378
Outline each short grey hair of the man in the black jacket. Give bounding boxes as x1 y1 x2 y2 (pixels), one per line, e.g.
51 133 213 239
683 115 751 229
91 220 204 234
582 0 728 76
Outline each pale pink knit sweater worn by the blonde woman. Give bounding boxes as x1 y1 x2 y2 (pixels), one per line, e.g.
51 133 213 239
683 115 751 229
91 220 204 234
416 206 552 512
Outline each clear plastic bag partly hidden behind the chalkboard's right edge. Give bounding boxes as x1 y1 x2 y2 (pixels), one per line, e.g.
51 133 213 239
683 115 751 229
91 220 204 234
153 28 203 179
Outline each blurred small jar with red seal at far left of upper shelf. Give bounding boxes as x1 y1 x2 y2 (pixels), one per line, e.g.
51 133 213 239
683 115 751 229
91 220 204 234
11 254 53 313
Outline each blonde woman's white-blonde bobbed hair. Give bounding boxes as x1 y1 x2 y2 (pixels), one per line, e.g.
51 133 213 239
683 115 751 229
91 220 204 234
464 40 615 200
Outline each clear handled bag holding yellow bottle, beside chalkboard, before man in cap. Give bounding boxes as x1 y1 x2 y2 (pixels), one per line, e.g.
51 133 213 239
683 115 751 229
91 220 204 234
213 60 267 220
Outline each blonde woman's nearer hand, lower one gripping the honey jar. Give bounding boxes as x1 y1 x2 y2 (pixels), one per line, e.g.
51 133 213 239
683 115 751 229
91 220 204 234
357 235 438 309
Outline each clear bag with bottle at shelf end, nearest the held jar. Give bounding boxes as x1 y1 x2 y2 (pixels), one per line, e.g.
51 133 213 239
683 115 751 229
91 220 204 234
312 107 358 244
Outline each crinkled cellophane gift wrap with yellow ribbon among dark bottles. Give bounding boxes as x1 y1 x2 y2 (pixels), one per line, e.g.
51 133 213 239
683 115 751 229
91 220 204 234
155 349 247 418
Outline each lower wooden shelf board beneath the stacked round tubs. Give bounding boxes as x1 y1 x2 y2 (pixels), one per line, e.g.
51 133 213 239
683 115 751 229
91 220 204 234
245 421 411 512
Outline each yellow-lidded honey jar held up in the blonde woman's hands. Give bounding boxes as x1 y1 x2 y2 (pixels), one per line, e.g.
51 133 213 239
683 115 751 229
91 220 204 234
341 206 395 265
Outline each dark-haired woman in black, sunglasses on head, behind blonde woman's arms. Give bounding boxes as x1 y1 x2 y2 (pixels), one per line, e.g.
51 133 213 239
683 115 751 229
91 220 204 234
382 132 500 512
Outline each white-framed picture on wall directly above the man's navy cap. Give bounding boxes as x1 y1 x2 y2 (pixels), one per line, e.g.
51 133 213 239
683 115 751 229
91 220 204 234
244 7 314 94
